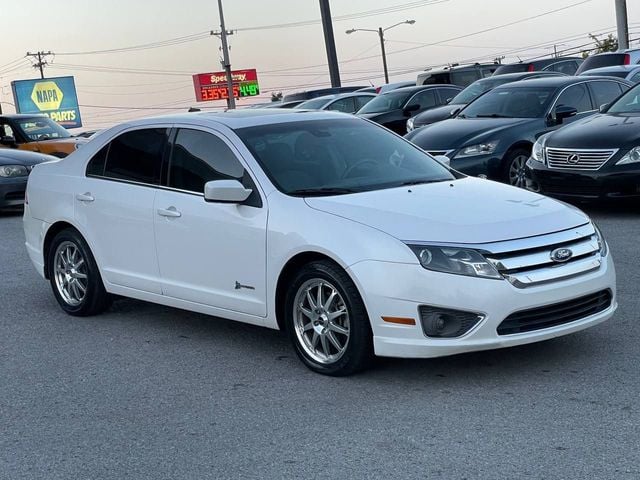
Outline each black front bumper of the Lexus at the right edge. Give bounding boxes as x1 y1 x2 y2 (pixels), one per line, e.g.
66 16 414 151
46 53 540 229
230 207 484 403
527 160 640 200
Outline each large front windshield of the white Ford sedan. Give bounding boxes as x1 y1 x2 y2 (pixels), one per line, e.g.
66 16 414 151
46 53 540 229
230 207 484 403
236 118 457 196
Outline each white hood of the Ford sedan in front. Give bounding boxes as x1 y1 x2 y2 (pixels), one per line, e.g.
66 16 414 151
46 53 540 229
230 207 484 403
306 177 589 244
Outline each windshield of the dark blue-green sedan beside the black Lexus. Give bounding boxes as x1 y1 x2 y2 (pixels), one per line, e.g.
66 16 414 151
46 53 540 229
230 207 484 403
459 85 556 118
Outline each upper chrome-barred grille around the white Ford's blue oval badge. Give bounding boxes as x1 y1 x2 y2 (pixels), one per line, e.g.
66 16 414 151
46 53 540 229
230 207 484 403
485 225 602 288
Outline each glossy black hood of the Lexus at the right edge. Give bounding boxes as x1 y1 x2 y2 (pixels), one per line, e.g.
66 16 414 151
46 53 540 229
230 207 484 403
546 113 640 148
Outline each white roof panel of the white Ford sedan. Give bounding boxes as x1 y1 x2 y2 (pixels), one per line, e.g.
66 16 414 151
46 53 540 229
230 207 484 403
120 108 357 130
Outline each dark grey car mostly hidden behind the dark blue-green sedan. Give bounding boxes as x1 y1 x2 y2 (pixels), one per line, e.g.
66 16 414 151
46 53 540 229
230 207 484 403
407 72 562 132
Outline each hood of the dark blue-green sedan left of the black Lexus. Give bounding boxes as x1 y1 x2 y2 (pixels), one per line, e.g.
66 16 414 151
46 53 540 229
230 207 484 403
406 118 540 150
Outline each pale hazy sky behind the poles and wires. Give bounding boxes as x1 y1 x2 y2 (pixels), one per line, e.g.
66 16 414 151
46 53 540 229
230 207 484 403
0 0 640 131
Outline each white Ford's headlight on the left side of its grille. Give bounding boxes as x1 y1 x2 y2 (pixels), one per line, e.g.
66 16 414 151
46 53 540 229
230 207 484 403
409 245 503 279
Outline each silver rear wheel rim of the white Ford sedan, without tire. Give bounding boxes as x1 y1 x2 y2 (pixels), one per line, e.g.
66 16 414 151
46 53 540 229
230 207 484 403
53 241 88 307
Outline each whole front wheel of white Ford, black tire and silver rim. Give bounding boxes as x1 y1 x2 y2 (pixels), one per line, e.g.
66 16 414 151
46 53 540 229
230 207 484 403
285 261 373 376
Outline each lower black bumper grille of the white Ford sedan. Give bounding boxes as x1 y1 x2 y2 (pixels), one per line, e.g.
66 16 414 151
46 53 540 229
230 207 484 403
497 290 613 335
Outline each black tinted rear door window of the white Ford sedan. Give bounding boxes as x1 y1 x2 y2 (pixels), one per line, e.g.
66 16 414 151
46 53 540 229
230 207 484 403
104 128 167 185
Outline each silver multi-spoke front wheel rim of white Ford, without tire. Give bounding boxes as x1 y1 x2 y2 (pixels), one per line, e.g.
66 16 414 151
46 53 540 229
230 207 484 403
293 278 350 364
